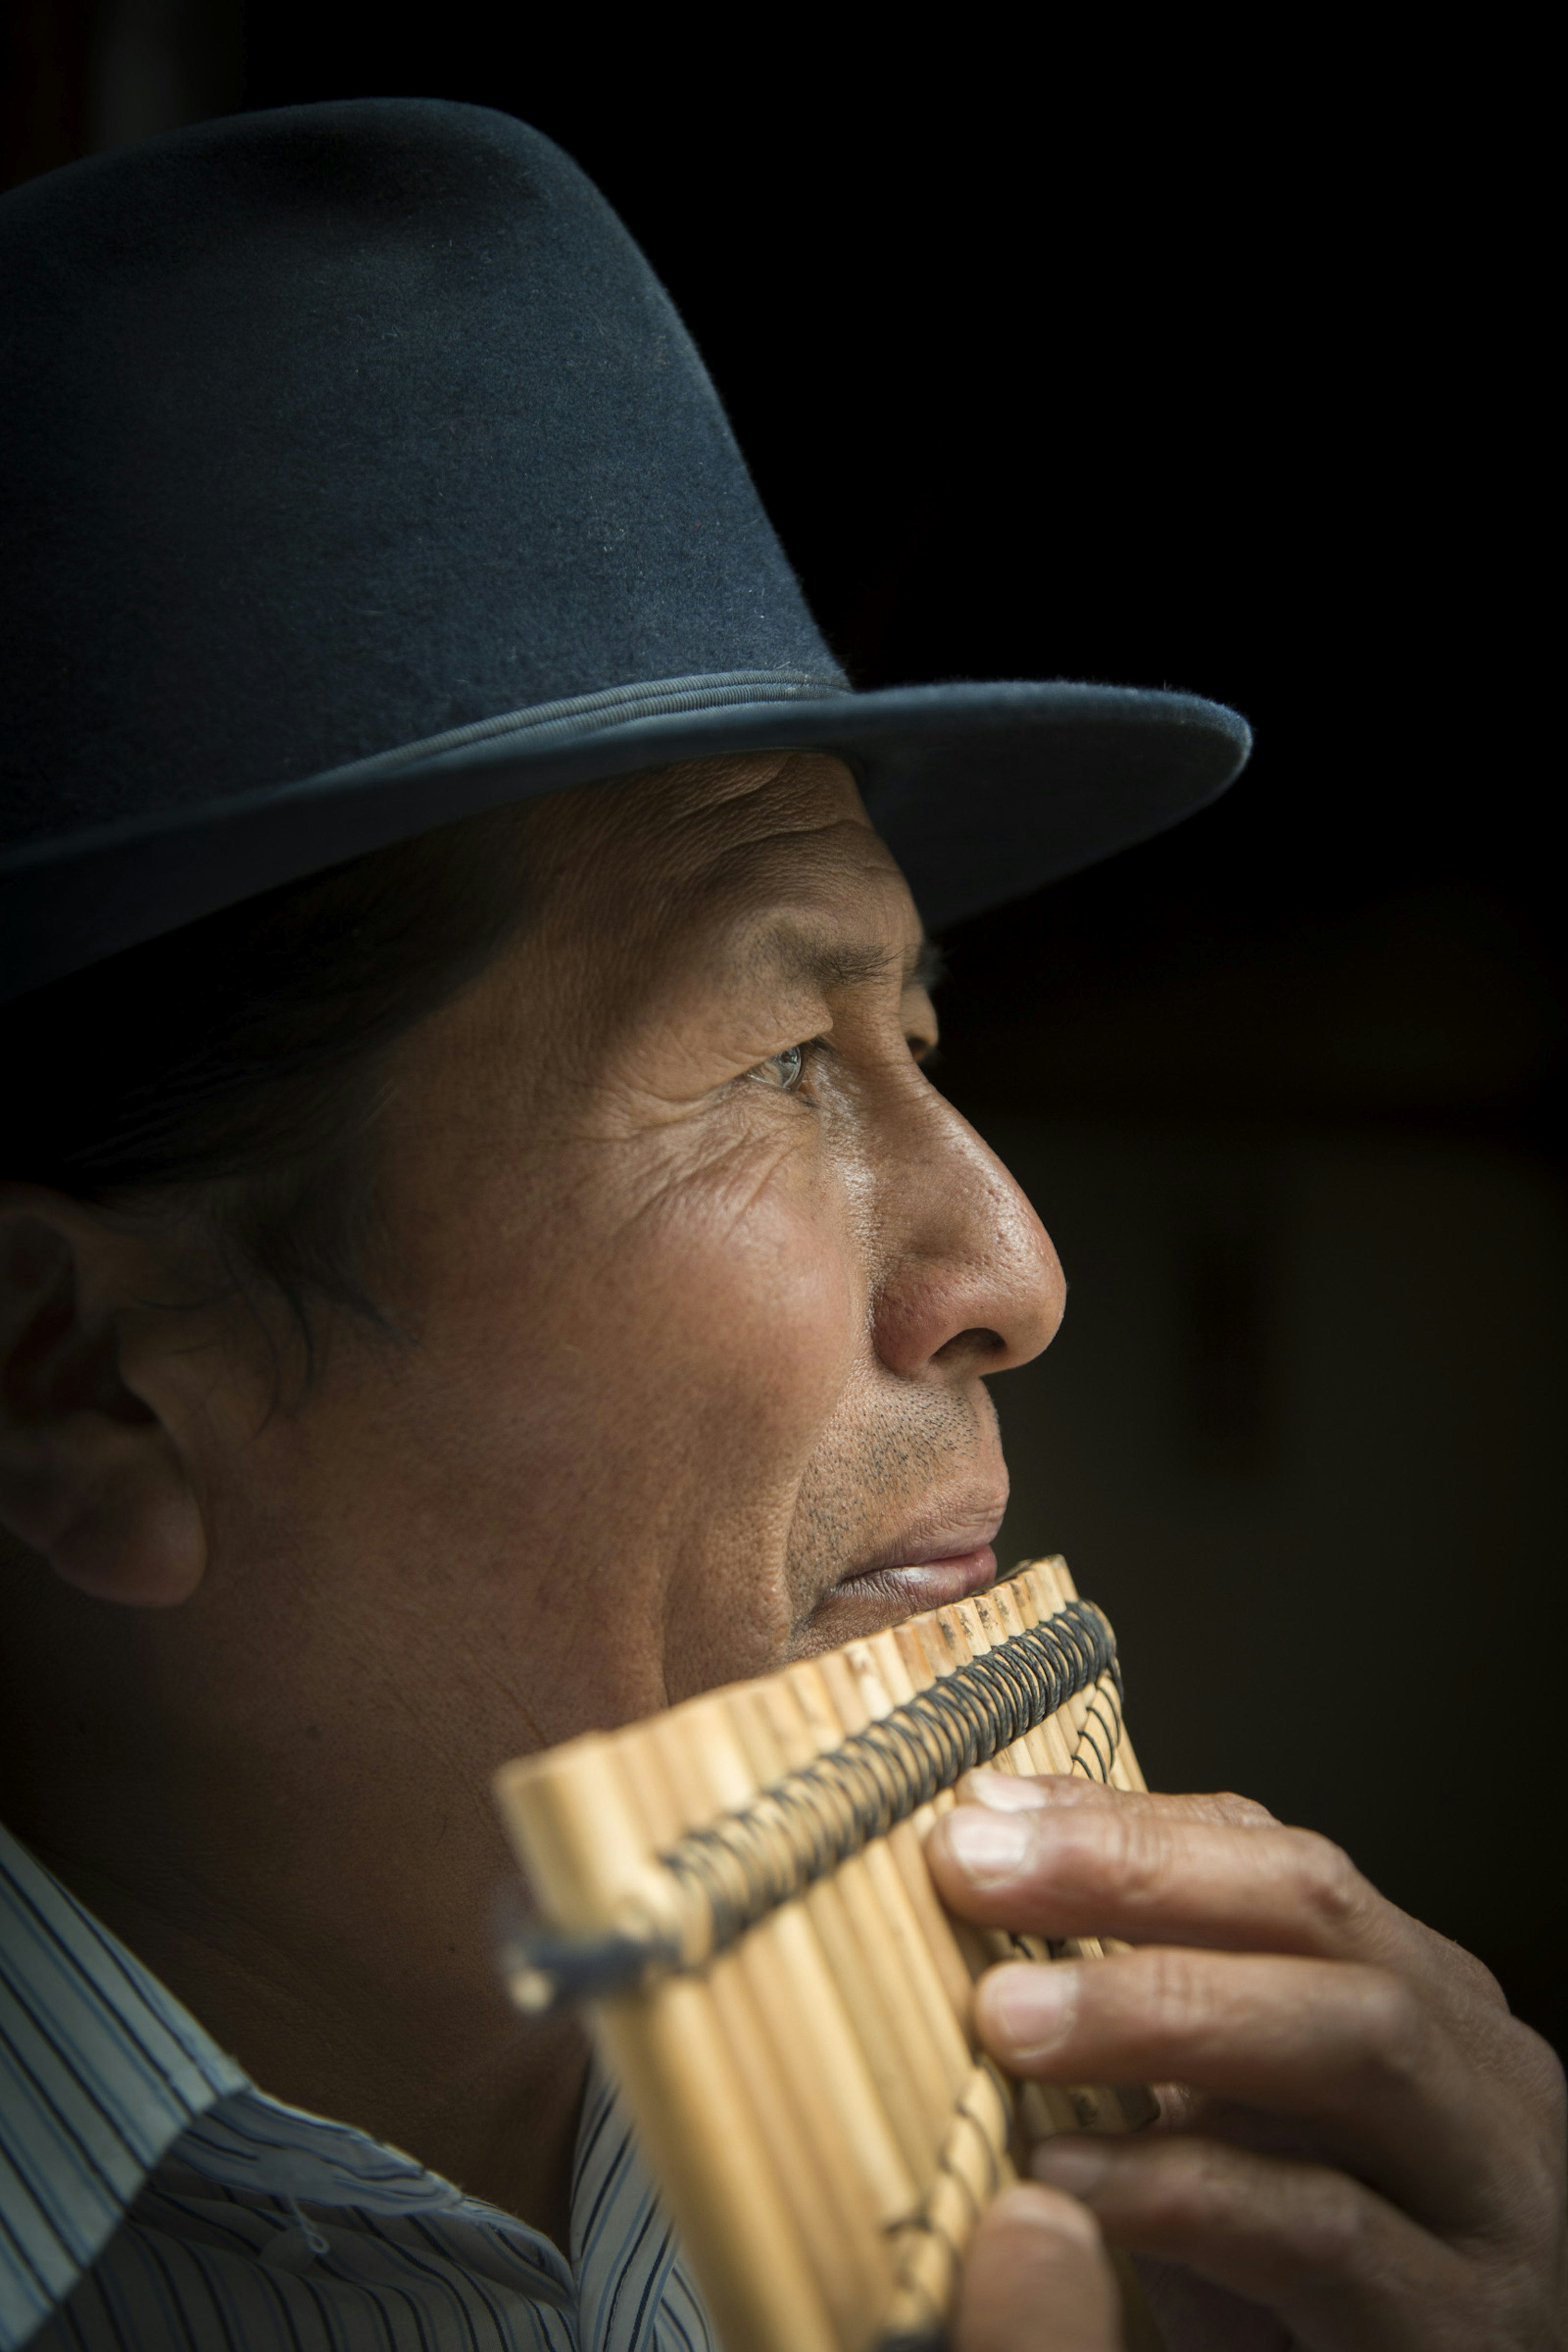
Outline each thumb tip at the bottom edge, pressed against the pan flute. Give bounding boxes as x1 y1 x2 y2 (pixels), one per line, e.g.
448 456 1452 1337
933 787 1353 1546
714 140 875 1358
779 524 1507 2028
954 2183 1121 2352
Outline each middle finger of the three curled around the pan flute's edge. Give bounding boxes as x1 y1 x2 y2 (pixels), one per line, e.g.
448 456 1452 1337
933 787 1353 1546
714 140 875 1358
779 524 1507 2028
976 1945 1516 2227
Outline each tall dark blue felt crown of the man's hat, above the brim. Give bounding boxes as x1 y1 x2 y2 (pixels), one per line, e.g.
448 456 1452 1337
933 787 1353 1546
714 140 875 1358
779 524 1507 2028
0 99 839 851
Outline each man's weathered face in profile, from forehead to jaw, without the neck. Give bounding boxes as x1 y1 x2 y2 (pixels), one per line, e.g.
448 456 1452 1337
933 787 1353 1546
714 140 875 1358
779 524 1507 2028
101 755 1062 1795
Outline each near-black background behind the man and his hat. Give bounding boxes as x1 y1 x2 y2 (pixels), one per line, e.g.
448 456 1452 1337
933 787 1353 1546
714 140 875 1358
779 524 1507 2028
0 0 1568 2046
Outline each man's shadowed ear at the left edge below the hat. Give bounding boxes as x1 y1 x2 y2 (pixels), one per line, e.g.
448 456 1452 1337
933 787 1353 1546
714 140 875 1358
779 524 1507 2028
0 1185 207 1609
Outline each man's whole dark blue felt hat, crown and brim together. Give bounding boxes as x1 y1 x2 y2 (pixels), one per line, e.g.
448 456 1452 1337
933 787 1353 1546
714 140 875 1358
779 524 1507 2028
0 99 1248 995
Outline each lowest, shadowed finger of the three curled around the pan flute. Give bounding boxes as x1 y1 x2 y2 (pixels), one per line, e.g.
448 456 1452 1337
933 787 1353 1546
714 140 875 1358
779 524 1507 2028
1030 2133 1495 2352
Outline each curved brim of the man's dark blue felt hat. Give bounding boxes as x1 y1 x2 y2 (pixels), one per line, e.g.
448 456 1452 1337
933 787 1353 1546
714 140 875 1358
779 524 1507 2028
0 682 1251 997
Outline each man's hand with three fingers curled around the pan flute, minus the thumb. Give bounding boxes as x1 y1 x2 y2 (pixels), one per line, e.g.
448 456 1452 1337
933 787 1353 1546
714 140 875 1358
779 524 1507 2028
926 1773 1568 2352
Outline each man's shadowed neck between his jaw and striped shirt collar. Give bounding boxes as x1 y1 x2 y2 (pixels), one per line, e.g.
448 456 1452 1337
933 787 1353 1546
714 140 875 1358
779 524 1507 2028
0 1571 588 2251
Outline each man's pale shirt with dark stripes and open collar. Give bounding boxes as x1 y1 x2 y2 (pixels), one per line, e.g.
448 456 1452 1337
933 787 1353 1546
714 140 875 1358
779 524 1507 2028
0 1828 717 2352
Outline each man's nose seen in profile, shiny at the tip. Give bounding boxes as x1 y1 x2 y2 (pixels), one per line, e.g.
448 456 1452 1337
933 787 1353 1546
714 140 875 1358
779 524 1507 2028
875 1077 1067 1381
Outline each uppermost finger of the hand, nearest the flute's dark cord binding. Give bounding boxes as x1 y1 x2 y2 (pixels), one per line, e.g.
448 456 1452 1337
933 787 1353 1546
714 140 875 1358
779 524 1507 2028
926 1773 1483 1985
